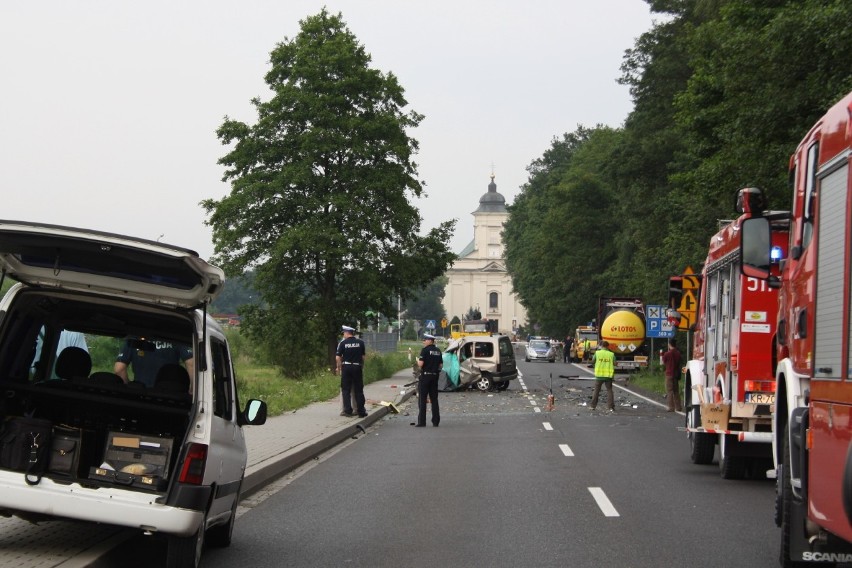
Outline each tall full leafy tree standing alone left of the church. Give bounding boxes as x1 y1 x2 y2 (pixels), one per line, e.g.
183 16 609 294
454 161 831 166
202 9 454 374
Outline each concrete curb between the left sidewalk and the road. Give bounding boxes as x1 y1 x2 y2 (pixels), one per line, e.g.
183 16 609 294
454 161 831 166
240 382 417 498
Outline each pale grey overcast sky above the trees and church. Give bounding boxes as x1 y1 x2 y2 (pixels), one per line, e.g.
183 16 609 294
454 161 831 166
0 0 651 258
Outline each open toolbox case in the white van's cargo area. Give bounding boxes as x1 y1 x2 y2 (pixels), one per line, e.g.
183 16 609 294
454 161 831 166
89 432 174 491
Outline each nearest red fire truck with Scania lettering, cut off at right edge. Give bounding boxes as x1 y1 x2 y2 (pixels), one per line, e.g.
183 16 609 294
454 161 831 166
742 93 852 566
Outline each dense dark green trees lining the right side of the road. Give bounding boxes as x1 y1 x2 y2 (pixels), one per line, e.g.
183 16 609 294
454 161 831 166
503 0 852 337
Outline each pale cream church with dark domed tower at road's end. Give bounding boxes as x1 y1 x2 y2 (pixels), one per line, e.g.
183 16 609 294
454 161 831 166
444 174 527 335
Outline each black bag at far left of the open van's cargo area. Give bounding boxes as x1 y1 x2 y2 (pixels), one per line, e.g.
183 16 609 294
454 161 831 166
0 416 52 485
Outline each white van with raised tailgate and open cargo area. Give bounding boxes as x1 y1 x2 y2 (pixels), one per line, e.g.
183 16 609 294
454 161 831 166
0 221 266 566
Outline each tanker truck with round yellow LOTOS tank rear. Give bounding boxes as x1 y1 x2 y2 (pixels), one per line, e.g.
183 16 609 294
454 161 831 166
598 297 648 371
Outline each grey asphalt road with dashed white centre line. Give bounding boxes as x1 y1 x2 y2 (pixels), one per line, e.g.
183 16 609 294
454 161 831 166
190 362 780 568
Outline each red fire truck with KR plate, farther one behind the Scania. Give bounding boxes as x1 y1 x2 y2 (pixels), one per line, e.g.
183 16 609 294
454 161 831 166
683 188 789 479
